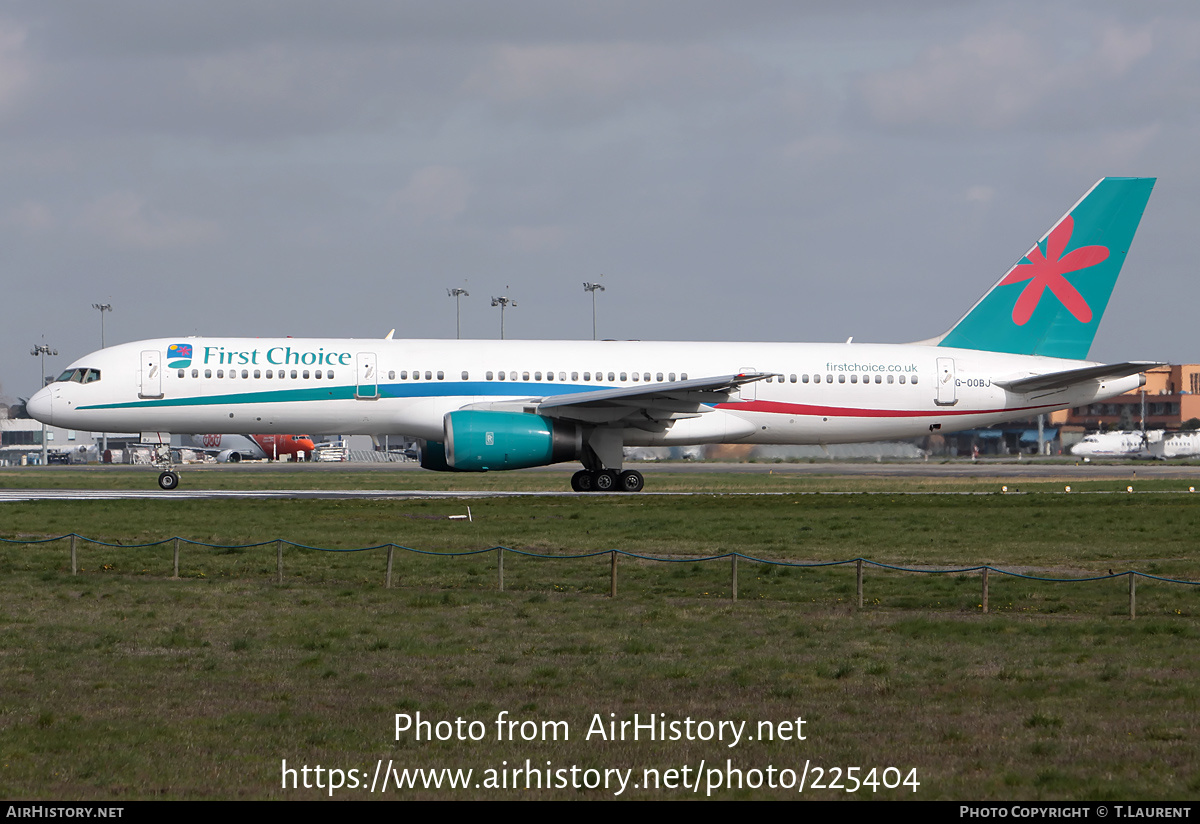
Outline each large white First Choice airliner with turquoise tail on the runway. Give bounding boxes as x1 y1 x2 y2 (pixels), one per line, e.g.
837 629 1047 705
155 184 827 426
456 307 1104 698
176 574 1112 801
28 178 1156 492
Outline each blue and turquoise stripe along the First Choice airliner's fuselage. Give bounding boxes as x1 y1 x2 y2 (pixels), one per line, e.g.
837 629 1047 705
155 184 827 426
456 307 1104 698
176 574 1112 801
79 380 604 410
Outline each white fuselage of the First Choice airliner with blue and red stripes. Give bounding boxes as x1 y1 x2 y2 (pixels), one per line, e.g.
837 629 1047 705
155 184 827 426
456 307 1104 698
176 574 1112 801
29 338 1141 446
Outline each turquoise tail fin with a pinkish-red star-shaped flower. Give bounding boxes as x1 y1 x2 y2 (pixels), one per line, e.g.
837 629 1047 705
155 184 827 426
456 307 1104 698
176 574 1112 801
937 178 1156 360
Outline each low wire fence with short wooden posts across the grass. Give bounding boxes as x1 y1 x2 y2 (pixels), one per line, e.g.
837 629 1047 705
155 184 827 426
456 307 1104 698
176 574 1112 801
0 533 1200 619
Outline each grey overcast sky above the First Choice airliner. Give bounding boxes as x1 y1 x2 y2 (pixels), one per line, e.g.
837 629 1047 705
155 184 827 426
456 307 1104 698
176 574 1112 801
0 0 1200 401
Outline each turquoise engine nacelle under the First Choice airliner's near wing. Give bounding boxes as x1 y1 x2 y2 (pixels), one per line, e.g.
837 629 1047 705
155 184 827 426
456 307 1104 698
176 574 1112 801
446 409 583 473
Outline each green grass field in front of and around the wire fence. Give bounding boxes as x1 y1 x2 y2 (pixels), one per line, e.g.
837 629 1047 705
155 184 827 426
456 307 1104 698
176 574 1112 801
0 473 1200 801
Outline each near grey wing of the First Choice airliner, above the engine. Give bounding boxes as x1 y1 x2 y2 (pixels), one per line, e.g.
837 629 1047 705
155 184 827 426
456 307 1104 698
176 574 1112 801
467 372 775 425
